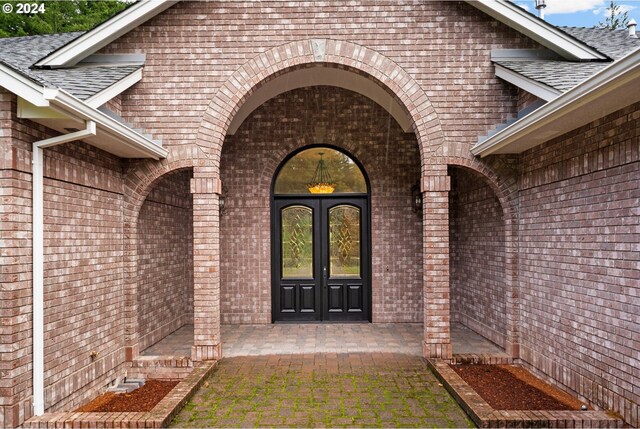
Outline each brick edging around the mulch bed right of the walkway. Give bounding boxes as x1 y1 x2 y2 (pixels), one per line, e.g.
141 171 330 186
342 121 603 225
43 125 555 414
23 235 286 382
427 359 624 428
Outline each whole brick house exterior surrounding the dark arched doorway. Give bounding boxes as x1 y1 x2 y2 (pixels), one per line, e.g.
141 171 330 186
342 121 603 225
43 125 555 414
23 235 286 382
0 0 640 427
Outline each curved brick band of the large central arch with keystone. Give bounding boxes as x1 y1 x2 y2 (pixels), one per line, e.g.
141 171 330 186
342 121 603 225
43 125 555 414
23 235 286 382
196 39 444 165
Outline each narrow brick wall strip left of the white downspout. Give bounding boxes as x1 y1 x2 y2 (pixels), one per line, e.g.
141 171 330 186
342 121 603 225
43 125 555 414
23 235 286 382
0 88 38 427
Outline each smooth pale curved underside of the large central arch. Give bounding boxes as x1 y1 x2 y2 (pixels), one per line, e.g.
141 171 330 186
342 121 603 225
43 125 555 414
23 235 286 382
227 67 412 135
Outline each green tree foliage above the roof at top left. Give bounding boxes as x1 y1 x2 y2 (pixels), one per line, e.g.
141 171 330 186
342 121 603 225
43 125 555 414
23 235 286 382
0 0 130 37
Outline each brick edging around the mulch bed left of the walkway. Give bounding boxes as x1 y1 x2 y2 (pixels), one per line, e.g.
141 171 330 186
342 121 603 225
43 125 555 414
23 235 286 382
22 361 218 429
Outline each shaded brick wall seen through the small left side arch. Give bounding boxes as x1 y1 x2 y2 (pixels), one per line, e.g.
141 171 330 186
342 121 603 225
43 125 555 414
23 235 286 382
137 170 193 350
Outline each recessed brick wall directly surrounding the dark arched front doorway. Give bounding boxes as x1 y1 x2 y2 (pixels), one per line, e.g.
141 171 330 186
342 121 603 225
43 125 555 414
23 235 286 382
221 87 422 323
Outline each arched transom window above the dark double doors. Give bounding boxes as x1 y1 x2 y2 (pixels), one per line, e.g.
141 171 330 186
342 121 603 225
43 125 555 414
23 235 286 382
274 147 367 195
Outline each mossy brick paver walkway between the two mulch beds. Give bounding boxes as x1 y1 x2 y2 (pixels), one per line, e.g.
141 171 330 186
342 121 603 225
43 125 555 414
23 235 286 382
172 353 473 427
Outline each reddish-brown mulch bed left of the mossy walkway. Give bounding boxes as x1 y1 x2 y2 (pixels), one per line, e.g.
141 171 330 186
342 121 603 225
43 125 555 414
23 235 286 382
76 380 178 413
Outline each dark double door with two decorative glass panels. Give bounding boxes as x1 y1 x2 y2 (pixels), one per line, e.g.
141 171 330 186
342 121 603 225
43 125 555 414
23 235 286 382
272 197 371 322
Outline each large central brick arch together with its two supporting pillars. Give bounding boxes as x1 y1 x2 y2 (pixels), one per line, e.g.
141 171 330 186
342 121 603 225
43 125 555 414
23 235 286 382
188 39 458 359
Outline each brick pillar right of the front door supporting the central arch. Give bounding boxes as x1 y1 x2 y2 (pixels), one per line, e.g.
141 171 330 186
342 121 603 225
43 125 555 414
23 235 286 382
421 174 452 359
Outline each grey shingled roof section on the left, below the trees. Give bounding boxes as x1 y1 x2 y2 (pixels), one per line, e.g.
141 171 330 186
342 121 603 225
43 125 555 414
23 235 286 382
0 32 142 100
